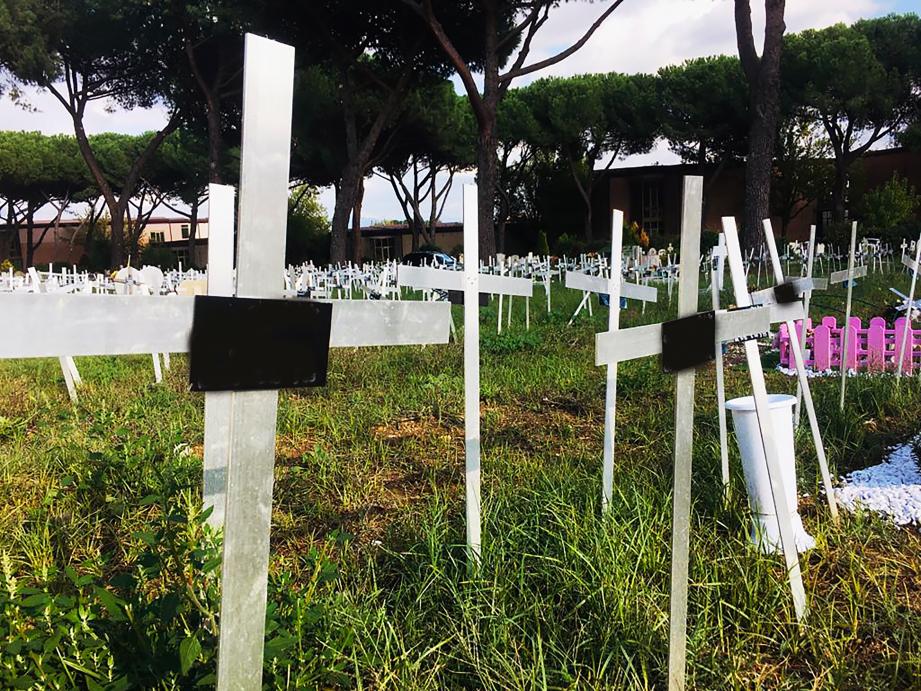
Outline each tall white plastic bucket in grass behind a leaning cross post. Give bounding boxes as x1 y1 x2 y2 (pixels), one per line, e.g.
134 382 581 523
726 394 815 554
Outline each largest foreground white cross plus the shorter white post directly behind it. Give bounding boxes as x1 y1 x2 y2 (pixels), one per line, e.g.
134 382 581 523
0 35 452 689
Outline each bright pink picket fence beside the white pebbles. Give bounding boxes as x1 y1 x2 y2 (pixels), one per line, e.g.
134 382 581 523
775 317 921 373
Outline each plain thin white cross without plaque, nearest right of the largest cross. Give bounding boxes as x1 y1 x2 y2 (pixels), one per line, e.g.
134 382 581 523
397 203 534 564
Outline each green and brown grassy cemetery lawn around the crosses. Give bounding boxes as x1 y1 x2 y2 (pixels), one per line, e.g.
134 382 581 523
0 273 921 689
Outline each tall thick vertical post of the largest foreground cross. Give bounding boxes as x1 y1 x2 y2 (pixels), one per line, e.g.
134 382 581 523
217 34 294 690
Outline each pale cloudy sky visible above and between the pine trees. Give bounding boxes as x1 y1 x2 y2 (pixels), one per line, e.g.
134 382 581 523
0 0 919 223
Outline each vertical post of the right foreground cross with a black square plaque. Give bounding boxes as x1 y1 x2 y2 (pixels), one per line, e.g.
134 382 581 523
668 176 703 691
